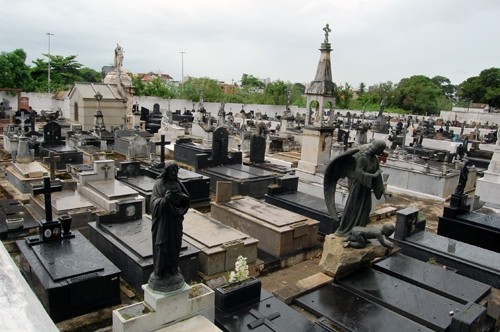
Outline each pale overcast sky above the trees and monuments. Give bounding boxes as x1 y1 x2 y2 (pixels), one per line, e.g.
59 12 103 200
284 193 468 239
0 0 500 87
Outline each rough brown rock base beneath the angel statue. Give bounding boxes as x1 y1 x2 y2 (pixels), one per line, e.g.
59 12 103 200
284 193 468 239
319 234 388 278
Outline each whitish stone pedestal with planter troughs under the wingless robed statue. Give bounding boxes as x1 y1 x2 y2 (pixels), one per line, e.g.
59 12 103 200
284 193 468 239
113 284 215 331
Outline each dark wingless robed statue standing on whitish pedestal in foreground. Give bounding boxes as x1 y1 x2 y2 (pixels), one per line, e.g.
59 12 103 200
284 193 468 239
148 161 190 292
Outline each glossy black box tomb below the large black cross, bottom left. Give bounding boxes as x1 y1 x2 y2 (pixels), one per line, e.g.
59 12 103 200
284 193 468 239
16 231 121 322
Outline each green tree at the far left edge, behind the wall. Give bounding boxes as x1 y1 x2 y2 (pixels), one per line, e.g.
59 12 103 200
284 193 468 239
0 49 32 91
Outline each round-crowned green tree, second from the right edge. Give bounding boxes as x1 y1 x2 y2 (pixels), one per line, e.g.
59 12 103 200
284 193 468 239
394 75 443 114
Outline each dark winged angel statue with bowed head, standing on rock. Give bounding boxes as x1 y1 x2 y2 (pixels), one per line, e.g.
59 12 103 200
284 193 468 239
323 140 386 237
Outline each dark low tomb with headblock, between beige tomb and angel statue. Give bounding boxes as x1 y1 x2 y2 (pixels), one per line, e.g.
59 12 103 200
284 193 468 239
265 175 343 236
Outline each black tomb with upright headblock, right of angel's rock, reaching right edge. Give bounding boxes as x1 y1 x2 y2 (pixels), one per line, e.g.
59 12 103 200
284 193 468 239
392 208 500 288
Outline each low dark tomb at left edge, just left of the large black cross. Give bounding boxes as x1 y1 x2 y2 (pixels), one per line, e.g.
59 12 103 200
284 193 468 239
0 199 39 240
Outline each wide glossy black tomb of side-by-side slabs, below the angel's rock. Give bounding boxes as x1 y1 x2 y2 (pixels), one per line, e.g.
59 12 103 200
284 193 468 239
295 254 492 331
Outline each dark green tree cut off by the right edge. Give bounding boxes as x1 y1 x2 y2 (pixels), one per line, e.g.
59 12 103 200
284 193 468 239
457 68 500 108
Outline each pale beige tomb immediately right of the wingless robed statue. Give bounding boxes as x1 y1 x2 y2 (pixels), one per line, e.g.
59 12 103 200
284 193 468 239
183 209 259 277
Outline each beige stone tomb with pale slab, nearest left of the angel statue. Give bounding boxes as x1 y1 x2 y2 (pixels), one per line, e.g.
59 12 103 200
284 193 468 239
211 197 319 257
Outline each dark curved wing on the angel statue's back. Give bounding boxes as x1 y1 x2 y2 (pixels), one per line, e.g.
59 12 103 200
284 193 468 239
323 149 359 222
